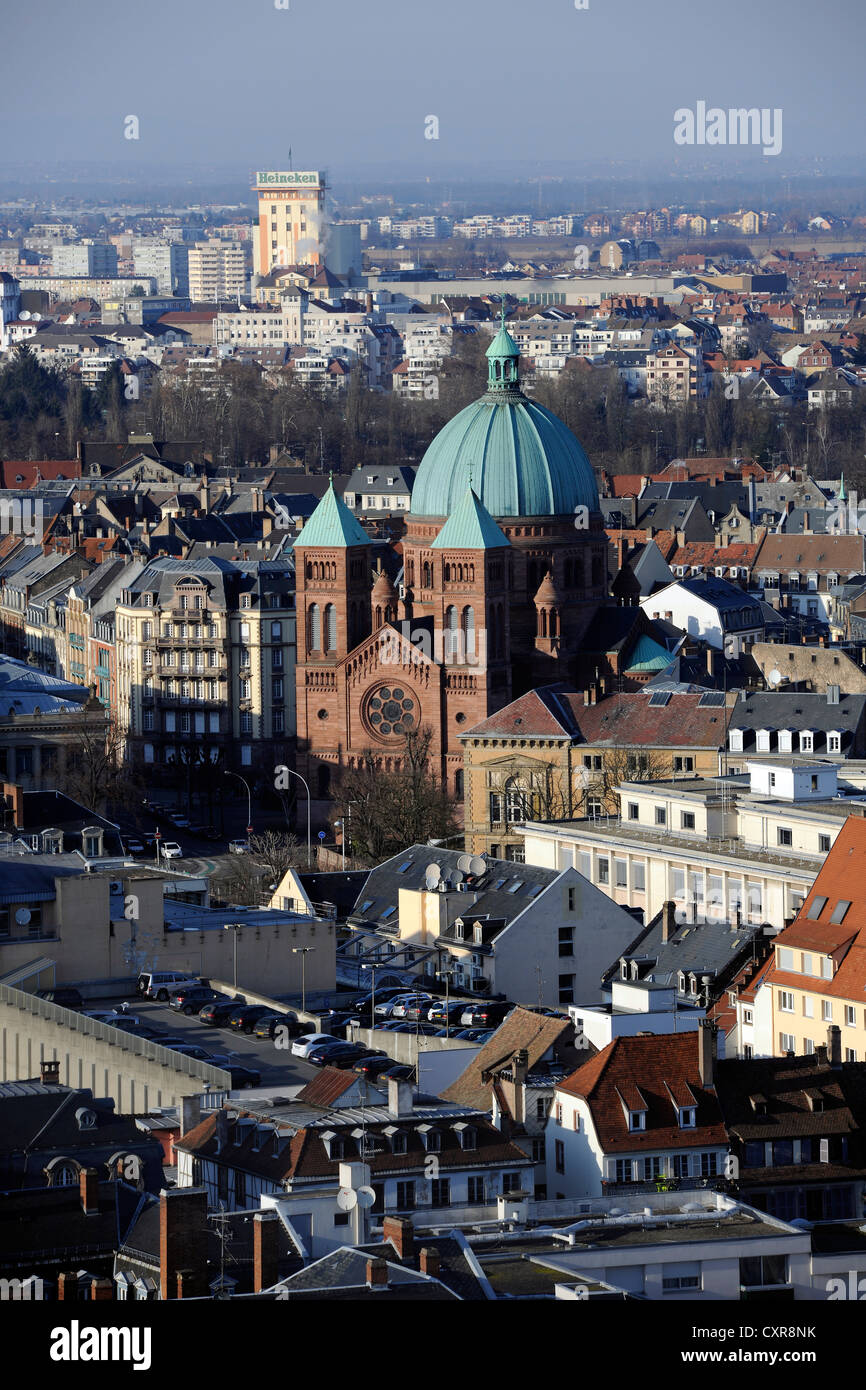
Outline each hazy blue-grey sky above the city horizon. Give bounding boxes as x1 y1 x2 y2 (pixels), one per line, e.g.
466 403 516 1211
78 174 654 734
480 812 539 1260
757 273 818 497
0 0 866 175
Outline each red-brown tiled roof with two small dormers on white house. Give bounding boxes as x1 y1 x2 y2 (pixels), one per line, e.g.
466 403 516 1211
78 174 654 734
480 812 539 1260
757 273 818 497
557 1033 727 1154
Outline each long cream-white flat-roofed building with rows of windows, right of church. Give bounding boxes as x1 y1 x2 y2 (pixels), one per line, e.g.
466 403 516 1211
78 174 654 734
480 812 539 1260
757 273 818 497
521 760 863 929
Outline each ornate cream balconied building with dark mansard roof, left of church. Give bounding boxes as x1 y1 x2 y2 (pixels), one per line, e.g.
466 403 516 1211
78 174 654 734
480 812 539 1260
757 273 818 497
117 559 295 776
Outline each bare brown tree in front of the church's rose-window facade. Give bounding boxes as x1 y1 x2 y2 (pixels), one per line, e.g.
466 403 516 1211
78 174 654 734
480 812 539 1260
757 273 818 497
334 726 457 863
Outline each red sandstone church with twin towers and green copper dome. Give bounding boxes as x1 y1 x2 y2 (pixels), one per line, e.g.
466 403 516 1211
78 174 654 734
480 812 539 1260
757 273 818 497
293 312 607 799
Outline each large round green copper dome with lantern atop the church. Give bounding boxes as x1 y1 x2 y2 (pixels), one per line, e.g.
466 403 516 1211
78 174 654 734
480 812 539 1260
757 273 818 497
410 307 599 517
